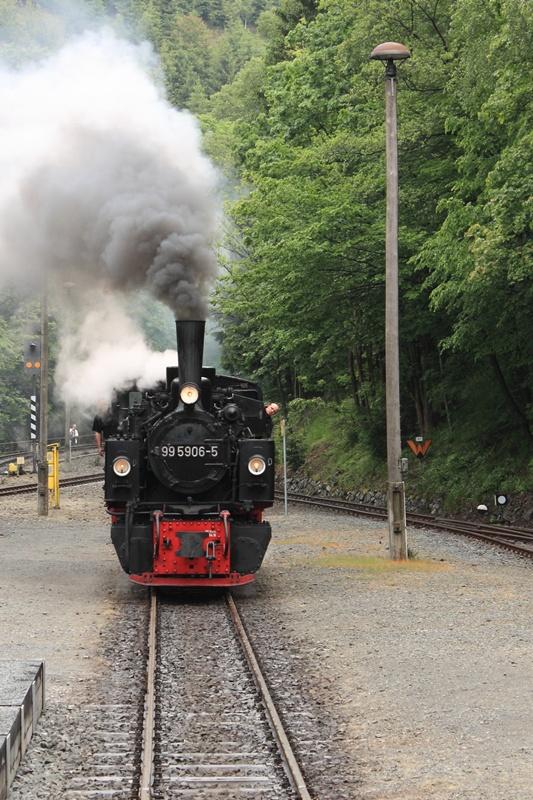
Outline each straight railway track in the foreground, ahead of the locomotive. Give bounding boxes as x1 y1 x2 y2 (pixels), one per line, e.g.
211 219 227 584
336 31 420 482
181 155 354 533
144 593 311 800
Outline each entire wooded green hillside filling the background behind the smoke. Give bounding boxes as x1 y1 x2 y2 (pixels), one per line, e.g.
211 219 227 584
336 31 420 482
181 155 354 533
0 0 533 505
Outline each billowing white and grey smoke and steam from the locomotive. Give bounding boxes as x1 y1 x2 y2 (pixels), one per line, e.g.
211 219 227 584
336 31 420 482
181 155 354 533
0 31 217 405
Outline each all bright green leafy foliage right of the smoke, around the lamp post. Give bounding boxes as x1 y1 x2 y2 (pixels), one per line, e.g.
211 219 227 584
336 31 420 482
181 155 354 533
204 0 533 500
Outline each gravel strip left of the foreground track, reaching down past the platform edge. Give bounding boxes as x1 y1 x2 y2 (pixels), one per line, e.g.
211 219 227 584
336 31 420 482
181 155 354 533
0 482 147 800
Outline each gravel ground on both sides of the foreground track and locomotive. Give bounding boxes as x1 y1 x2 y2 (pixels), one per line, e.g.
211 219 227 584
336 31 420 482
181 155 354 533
0 485 533 800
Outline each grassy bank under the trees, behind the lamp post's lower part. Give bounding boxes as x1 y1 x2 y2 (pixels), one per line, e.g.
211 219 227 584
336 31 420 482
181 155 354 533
288 401 533 513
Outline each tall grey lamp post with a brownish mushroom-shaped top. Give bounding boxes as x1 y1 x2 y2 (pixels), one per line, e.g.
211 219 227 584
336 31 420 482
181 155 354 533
370 42 411 560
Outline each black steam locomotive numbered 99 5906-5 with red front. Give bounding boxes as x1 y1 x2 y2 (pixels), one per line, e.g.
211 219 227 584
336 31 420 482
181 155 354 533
104 320 274 587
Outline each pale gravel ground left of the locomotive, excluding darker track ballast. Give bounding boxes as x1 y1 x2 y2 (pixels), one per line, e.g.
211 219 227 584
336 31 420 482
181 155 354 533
0 478 138 699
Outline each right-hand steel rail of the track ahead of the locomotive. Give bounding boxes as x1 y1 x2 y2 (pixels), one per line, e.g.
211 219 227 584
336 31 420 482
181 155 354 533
226 592 312 800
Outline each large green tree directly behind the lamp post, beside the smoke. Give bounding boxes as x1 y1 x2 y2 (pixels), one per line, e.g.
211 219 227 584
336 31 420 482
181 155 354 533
213 1 456 438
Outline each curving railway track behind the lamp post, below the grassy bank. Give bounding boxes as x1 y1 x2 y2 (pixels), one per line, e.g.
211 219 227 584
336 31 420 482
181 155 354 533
276 492 533 558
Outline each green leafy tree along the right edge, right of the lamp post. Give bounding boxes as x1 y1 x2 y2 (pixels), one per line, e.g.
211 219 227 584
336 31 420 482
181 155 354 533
418 0 533 439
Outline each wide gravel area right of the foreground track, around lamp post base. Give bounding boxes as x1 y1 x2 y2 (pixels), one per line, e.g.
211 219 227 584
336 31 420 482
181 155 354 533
237 509 533 800
